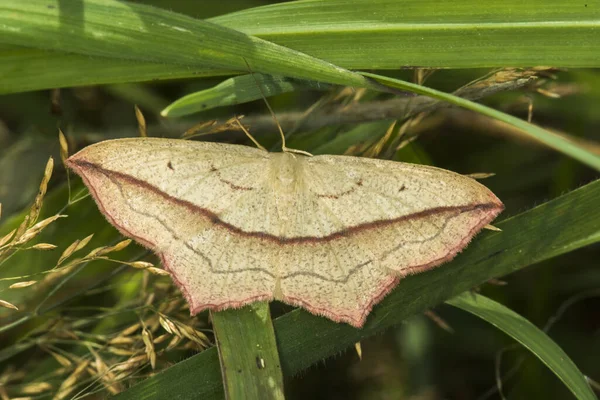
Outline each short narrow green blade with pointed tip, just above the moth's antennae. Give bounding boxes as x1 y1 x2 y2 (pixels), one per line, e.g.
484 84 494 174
161 74 331 117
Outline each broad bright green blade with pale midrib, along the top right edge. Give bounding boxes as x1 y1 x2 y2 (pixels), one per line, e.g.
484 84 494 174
210 0 600 69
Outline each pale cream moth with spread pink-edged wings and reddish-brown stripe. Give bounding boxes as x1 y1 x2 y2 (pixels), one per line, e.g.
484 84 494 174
67 138 503 327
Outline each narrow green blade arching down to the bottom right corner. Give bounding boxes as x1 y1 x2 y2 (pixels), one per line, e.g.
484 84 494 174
447 293 597 400
